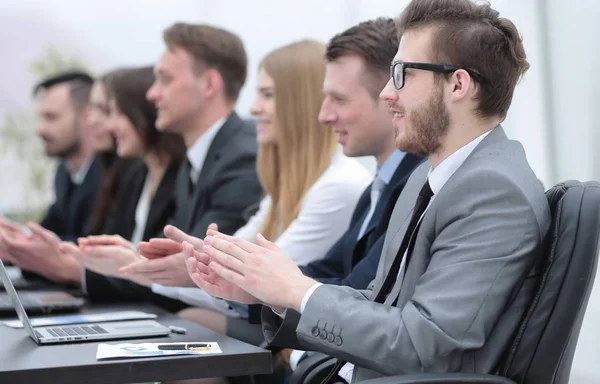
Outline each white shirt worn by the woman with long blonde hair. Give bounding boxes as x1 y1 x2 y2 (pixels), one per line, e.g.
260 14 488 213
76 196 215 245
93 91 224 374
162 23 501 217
152 152 372 316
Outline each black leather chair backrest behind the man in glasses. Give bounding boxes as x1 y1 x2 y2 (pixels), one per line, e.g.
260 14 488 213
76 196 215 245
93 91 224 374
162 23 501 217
500 181 600 384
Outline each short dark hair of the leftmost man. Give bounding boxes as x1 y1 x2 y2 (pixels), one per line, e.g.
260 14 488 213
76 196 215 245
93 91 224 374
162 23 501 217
33 71 94 111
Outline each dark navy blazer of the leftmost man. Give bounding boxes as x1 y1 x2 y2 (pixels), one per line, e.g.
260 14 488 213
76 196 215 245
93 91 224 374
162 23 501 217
40 159 102 241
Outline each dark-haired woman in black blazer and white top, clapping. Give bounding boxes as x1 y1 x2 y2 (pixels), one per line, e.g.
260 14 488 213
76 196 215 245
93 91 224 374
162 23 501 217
60 67 185 308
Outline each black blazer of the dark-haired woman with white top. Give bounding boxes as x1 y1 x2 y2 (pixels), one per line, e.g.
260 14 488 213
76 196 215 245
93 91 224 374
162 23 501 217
85 163 180 310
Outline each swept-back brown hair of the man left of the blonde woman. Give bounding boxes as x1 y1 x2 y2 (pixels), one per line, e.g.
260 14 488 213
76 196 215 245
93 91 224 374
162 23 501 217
163 23 248 102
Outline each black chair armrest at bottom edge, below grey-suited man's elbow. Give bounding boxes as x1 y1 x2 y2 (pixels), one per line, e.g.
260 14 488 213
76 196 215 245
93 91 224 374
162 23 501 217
360 373 515 384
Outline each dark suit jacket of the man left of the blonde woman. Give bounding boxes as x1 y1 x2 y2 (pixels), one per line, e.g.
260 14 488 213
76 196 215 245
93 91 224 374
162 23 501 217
86 112 263 311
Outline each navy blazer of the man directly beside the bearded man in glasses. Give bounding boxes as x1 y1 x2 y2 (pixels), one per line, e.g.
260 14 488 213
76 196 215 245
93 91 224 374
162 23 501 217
300 154 423 289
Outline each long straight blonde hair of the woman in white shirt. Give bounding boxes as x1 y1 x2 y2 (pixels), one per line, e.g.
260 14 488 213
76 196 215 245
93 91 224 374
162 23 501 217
257 40 336 240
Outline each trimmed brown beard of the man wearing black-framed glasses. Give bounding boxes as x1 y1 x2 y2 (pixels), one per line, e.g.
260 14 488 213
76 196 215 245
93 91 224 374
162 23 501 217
396 85 450 156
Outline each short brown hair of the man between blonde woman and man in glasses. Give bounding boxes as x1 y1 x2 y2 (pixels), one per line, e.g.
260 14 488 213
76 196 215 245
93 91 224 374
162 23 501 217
325 17 400 98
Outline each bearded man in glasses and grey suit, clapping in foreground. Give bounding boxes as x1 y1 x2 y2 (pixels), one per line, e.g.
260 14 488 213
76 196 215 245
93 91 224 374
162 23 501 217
185 0 550 382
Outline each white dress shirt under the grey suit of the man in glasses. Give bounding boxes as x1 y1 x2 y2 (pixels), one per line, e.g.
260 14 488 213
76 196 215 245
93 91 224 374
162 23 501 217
300 130 491 383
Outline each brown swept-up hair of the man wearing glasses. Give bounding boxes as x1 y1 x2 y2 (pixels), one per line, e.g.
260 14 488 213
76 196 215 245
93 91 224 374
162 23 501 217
397 0 529 119
